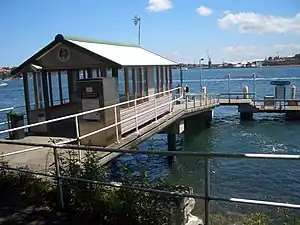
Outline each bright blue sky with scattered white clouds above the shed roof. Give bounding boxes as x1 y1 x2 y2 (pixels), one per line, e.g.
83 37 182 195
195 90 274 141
0 0 300 66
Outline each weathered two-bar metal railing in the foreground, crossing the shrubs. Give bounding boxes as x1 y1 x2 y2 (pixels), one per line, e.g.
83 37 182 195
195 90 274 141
0 141 300 225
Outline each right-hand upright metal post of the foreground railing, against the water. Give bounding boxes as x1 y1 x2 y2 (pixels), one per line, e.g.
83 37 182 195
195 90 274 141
204 158 210 225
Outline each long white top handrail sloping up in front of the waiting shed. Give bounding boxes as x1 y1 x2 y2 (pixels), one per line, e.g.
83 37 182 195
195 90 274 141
0 87 181 134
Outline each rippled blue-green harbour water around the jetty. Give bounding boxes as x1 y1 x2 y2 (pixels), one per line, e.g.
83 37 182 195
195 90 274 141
0 67 300 218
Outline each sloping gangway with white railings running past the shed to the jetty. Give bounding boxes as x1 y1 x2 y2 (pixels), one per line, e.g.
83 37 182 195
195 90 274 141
0 88 219 170
